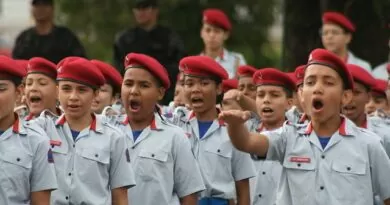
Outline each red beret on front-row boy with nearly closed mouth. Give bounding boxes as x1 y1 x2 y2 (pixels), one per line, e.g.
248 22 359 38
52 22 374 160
57 57 105 88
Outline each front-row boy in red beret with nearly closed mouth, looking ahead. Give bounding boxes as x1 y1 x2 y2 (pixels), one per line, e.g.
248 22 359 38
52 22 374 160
32 58 135 205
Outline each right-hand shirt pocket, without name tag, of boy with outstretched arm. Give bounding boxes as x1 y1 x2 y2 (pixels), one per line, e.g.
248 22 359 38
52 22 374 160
331 159 370 201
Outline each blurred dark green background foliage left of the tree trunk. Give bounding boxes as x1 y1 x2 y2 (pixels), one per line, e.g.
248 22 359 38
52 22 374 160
56 0 279 67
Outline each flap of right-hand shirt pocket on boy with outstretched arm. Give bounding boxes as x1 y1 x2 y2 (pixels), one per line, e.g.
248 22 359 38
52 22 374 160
332 160 367 175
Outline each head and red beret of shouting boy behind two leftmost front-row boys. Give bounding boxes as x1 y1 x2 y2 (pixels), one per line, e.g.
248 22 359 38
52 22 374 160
24 57 61 121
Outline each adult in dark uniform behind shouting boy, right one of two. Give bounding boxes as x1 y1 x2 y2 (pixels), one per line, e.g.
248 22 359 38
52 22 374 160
114 0 185 105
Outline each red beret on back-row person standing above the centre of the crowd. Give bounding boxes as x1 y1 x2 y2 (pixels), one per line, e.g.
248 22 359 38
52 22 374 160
203 9 232 31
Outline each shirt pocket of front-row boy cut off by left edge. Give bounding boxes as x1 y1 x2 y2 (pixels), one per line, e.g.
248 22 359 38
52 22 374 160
0 151 33 192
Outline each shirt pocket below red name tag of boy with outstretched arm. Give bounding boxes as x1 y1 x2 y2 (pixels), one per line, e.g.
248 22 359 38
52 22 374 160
283 158 316 200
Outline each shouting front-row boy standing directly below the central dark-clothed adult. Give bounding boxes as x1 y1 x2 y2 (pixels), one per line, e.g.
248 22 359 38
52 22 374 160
111 53 204 205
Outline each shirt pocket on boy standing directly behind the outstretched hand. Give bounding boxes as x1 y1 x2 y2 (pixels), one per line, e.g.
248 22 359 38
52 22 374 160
200 142 233 182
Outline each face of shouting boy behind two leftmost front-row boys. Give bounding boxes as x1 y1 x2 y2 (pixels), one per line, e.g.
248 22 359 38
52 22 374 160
24 73 58 115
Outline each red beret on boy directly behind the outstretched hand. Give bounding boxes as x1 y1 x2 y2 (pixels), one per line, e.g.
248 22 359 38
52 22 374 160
179 56 229 80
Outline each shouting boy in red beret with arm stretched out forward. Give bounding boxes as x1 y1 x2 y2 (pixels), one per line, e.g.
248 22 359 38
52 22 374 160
220 49 390 205
